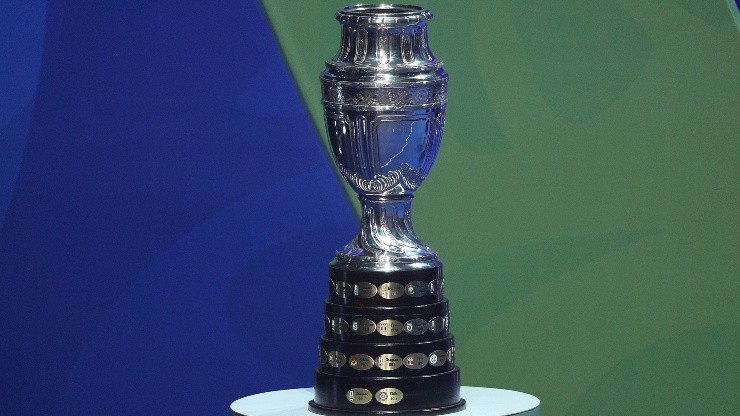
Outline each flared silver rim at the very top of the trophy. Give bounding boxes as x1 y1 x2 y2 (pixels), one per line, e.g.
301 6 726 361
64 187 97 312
336 4 432 25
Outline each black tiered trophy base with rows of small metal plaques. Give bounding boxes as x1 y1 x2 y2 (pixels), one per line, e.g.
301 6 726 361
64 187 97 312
309 263 465 415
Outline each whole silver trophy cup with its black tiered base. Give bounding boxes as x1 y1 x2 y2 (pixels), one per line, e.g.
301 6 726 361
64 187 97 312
309 5 465 414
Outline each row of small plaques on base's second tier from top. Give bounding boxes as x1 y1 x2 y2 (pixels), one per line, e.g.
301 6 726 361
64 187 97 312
326 315 450 337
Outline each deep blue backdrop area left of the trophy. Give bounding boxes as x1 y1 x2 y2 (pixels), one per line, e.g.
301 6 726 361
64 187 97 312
0 0 356 415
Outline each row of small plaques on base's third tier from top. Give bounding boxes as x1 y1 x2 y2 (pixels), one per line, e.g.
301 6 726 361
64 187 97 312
319 347 455 371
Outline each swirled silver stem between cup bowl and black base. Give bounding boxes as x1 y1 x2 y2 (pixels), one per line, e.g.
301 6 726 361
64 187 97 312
337 195 437 268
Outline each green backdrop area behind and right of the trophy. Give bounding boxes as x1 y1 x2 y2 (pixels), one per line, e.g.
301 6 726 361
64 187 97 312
263 0 740 416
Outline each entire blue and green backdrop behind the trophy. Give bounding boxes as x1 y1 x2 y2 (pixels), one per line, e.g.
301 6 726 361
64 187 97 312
0 0 740 416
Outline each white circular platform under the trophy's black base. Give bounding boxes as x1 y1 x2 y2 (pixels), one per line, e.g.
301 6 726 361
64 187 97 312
231 386 540 416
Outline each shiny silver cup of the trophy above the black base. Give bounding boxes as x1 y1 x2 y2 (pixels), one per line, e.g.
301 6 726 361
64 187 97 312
321 5 447 268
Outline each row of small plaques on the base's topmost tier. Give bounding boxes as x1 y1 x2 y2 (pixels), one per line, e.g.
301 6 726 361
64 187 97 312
331 280 444 299
